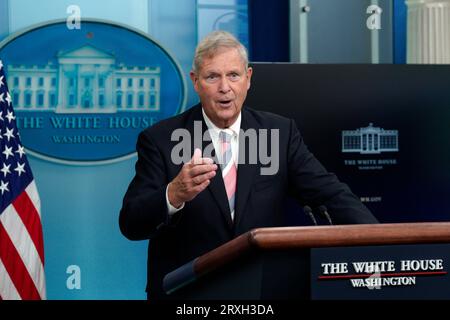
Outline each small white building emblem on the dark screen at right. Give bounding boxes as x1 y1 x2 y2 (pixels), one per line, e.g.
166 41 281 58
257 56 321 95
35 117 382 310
342 123 398 154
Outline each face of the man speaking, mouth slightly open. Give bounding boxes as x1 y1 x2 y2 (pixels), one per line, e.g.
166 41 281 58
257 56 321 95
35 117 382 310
190 48 252 128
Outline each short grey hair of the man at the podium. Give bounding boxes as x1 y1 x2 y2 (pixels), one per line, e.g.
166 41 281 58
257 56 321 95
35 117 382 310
192 31 248 74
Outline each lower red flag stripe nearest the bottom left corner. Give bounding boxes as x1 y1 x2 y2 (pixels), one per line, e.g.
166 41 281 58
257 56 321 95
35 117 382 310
0 221 39 299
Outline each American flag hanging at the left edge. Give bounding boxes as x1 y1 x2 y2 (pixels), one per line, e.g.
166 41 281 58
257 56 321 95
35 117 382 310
0 60 46 300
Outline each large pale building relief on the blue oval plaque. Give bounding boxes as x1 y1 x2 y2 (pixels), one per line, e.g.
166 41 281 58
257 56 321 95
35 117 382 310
8 45 161 113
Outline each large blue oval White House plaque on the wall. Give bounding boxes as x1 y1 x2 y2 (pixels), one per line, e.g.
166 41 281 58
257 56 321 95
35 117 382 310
0 19 186 164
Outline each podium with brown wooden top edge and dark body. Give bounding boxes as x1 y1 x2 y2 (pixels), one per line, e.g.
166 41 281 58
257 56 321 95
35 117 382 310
164 222 450 300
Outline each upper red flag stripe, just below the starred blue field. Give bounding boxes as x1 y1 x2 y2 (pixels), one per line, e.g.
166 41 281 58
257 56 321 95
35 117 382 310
13 185 44 263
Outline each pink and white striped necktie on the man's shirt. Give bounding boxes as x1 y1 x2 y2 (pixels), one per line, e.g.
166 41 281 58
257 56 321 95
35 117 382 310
219 131 237 220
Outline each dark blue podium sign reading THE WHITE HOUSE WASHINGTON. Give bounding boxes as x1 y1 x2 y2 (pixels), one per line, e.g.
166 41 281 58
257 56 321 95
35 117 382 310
311 244 450 300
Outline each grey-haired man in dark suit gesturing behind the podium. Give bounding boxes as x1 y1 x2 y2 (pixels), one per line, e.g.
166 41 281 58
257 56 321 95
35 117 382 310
119 31 377 299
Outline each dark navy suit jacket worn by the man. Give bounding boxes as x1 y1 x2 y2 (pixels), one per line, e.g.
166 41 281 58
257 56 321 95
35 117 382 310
119 105 377 298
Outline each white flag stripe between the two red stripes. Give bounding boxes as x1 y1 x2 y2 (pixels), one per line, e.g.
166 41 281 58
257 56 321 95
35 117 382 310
0 205 45 296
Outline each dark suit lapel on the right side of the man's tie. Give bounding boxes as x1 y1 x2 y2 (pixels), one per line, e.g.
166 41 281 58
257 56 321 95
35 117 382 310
234 107 261 232
